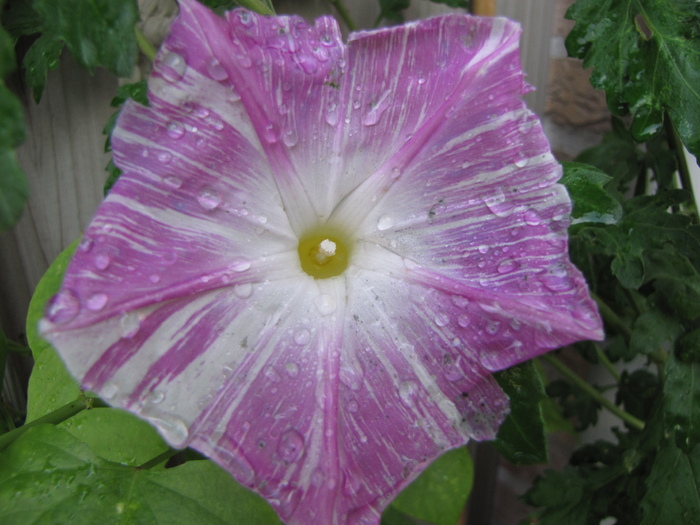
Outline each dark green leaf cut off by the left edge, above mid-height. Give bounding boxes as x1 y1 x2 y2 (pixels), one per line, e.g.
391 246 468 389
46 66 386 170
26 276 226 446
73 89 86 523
0 85 29 231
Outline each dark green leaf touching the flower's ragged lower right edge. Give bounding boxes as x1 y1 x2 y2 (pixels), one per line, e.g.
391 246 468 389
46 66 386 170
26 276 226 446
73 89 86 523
494 361 549 465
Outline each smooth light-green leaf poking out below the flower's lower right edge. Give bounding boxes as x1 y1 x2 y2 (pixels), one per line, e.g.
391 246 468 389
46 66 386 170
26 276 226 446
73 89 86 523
382 447 474 525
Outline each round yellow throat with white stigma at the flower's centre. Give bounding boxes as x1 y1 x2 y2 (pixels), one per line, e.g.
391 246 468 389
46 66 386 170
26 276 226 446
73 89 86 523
299 229 351 279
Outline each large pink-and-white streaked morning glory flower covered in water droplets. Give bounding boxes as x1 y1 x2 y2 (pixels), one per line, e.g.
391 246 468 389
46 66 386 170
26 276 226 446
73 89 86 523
41 0 602 524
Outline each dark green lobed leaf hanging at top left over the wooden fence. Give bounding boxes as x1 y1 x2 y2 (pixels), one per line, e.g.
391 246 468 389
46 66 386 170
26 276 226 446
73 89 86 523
33 0 139 77
